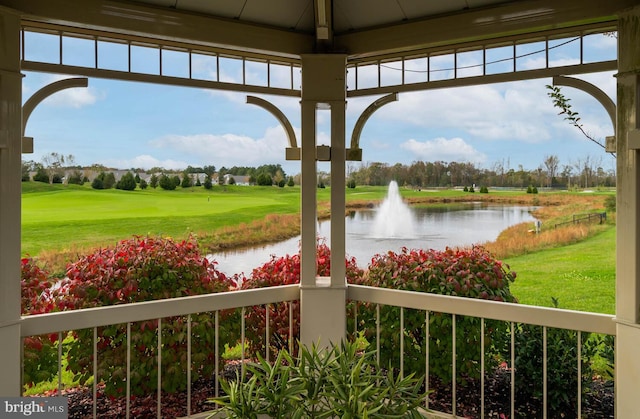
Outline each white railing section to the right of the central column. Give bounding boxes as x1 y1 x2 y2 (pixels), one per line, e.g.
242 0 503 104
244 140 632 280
347 285 616 418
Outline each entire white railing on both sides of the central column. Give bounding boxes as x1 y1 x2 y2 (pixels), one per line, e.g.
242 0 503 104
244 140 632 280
21 285 616 417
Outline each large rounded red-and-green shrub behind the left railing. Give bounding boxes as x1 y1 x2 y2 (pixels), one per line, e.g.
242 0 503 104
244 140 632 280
58 237 237 395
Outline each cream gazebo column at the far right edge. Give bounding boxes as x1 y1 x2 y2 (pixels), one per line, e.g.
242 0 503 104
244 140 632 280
616 6 640 418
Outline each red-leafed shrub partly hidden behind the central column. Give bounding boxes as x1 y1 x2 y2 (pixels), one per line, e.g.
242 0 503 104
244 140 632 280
242 239 364 353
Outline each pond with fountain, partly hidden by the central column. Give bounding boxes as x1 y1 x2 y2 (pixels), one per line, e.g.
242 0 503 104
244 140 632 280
210 186 536 275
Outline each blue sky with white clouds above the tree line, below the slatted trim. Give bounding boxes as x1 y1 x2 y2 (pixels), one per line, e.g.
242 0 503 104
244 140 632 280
23 36 616 175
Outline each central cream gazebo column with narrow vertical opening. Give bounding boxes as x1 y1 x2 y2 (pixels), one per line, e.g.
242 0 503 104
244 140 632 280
300 54 346 347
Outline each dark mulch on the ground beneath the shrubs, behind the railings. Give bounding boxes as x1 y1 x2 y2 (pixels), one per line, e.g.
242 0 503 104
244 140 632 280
47 368 614 419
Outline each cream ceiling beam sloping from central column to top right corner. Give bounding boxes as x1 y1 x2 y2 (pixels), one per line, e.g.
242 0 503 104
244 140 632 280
334 0 637 60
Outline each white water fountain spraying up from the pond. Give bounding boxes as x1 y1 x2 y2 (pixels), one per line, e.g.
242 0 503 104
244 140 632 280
371 180 416 239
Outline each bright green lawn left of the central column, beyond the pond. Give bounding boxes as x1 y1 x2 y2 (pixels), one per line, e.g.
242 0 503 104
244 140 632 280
22 182 300 255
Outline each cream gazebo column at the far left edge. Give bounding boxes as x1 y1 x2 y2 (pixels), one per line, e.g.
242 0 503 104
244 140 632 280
0 7 22 396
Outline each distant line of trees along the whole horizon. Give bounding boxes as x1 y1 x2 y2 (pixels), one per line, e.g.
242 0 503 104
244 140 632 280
22 153 616 190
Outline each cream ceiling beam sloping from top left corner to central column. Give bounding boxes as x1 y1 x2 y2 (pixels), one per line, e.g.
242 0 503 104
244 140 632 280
0 0 315 57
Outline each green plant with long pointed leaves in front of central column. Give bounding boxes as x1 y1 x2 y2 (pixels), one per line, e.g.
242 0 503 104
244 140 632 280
213 343 425 419
